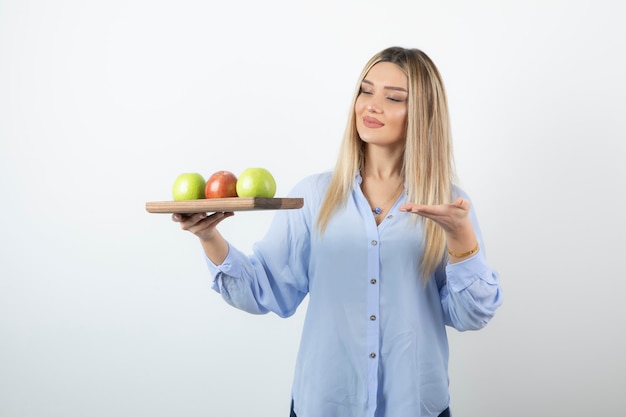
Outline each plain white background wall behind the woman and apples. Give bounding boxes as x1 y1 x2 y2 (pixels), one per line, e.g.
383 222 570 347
0 0 626 417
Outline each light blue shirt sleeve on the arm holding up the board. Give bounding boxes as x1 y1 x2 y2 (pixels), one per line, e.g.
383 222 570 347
206 175 313 317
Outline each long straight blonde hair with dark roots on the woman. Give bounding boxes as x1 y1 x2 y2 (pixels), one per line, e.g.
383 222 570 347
317 47 455 280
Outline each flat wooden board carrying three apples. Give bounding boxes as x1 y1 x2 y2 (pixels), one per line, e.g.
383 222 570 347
146 197 304 214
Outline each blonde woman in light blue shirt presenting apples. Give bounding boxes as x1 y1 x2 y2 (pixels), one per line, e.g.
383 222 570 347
174 47 501 417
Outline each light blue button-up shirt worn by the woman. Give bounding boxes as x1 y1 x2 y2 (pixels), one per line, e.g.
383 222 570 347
207 173 501 417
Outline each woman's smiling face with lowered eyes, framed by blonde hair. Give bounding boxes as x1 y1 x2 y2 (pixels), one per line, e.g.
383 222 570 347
354 62 409 145
